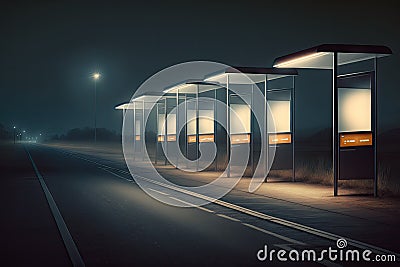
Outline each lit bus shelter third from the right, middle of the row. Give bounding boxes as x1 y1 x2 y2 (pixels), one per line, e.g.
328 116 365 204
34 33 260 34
164 80 221 171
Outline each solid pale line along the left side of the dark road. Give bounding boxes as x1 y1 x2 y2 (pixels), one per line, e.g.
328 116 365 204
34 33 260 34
24 146 85 266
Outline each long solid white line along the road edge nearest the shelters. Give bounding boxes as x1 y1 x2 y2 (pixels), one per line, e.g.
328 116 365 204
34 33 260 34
56 149 400 258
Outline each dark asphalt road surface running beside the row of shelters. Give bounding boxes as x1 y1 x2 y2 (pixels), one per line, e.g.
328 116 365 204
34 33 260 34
0 144 398 266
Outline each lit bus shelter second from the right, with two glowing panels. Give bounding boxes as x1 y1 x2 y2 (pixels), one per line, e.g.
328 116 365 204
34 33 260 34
205 67 297 179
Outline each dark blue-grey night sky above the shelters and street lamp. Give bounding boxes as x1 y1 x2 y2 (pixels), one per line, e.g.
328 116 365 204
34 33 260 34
0 0 400 138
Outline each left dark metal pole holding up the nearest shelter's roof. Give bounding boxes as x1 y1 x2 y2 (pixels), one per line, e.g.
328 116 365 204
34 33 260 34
332 52 339 196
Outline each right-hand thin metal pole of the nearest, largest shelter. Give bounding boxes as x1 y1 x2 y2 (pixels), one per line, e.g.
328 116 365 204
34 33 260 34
373 57 378 197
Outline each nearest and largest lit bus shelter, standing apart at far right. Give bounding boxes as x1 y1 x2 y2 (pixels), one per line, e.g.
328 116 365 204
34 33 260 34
274 44 392 196
